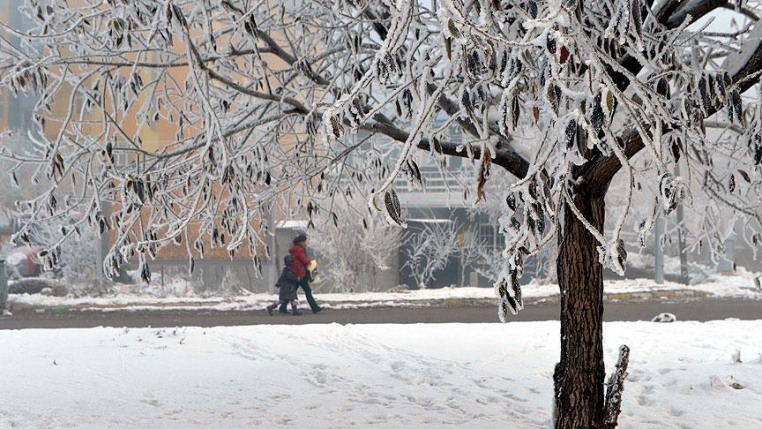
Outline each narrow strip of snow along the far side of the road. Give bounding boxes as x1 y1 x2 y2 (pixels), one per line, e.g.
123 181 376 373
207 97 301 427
8 271 762 311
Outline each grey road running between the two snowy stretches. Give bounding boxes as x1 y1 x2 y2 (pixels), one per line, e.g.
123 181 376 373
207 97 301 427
0 300 762 329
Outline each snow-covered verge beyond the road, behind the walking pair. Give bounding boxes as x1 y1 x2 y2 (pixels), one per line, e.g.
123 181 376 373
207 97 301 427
2 276 762 312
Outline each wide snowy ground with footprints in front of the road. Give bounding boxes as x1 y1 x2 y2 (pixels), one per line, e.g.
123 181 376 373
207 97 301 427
0 320 762 429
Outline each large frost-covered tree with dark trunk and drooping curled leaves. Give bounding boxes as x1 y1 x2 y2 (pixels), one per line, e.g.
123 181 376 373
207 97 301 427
0 0 762 428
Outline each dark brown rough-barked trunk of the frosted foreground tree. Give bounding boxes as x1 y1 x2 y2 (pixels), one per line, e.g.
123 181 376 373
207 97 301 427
553 196 606 429
